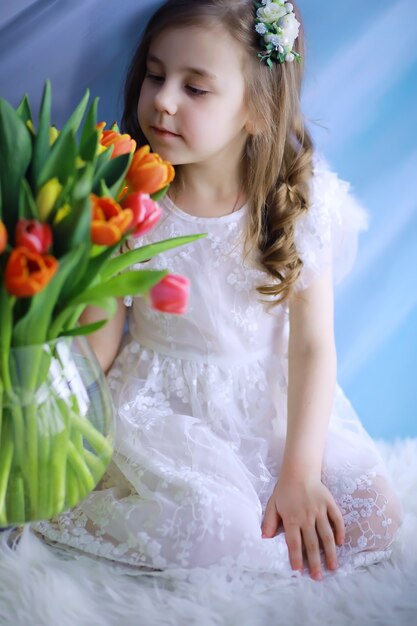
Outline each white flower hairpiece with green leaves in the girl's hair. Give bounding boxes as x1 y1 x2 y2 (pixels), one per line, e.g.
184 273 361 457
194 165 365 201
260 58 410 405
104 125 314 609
255 0 301 69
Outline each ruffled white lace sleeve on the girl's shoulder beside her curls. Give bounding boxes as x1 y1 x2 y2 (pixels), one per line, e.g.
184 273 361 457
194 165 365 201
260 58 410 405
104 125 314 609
295 154 368 291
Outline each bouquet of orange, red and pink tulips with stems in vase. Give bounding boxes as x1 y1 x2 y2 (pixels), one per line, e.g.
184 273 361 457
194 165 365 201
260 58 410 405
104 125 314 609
0 82 199 526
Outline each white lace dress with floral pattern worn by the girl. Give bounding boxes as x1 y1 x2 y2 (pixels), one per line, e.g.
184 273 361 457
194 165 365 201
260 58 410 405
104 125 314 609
32 158 399 577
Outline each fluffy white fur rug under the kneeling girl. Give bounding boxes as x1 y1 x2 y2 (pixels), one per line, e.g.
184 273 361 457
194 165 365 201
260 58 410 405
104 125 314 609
0 439 417 626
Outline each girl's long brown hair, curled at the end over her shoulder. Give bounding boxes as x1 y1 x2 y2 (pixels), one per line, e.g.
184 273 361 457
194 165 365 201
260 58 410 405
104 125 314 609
122 0 313 303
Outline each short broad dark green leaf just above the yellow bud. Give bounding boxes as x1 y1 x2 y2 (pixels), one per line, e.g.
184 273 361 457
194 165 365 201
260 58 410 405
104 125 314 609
37 126 77 187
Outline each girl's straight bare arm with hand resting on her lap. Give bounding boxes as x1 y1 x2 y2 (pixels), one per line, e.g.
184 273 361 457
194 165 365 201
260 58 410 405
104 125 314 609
262 270 344 579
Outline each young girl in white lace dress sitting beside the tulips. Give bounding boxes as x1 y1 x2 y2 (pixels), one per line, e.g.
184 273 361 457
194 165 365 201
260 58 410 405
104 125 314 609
34 0 401 580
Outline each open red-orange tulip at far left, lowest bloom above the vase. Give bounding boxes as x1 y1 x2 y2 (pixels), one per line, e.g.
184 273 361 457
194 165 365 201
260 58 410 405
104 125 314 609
4 247 59 298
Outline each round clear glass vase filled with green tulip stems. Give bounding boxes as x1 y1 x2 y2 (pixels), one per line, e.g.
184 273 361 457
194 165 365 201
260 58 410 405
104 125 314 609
0 337 115 527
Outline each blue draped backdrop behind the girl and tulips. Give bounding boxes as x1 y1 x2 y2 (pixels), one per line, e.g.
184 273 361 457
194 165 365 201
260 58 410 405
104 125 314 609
0 0 417 439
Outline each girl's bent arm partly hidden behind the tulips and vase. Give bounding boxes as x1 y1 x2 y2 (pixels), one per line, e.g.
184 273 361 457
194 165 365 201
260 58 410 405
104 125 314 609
80 298 126 372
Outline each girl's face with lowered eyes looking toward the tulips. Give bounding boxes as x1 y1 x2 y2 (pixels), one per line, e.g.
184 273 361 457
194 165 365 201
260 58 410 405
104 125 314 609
138 25 248 165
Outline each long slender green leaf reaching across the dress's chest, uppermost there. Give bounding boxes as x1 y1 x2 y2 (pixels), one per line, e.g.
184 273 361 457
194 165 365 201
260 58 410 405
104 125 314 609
100 233 207 280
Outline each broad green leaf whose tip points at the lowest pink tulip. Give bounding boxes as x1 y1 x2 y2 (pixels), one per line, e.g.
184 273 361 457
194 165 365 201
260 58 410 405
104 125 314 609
72 270 168 304
